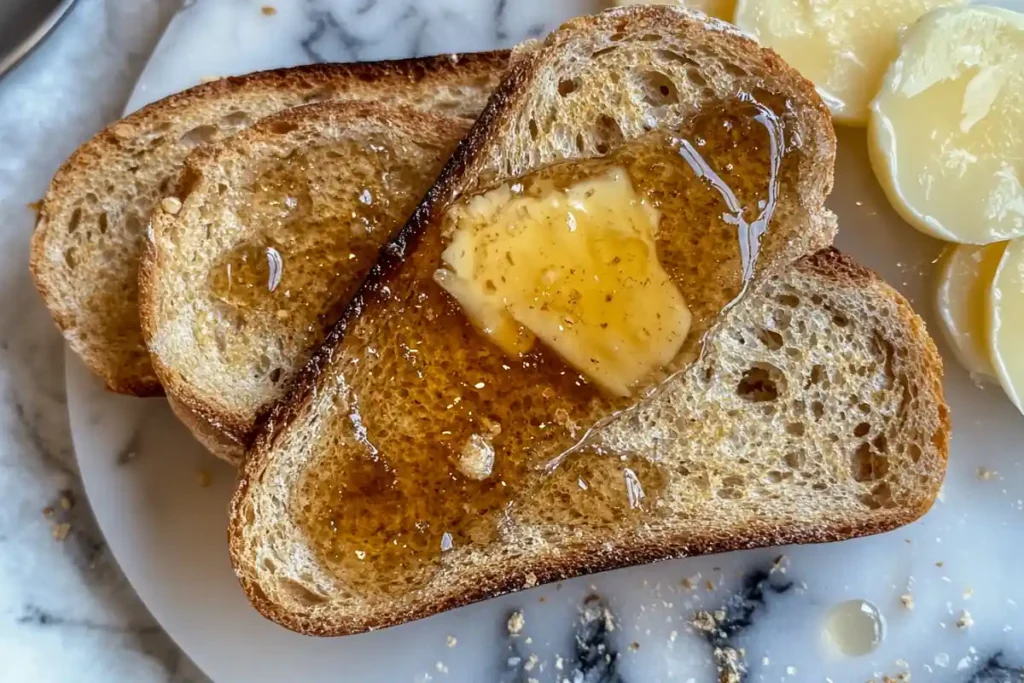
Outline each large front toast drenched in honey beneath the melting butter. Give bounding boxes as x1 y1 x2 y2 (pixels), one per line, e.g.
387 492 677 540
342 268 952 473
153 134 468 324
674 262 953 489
229 7 884 635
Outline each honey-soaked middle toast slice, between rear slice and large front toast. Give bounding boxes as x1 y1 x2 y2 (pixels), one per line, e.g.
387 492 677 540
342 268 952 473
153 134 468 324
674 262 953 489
139 101 471 464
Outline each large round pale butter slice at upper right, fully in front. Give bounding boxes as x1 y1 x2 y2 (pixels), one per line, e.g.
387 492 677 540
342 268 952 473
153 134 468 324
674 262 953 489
868 7 1024 245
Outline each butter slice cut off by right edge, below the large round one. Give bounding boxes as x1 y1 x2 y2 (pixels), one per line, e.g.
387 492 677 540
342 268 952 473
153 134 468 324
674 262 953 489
988 240 1024 413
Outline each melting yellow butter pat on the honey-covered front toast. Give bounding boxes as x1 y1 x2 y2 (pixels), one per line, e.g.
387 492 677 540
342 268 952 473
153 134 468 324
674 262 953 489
434 167 690 395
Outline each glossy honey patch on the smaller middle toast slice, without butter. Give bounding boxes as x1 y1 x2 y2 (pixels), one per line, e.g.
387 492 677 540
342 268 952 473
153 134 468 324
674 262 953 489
208 139 446 352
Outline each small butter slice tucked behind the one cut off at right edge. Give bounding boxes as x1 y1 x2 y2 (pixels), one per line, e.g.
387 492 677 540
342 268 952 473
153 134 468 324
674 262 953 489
936 242 1006 377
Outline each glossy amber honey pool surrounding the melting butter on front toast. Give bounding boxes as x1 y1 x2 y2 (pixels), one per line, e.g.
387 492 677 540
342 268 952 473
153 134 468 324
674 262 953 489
292 100 797 593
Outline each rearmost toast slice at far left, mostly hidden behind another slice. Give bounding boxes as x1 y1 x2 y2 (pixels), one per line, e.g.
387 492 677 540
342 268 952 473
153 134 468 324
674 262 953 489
31 52 508 396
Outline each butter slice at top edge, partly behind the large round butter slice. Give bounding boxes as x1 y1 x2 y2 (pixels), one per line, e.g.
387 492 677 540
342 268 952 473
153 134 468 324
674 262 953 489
735 0 966 125
